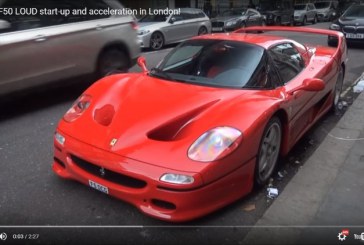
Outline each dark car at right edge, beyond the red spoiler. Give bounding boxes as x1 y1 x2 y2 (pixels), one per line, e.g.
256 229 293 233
328 4 364 46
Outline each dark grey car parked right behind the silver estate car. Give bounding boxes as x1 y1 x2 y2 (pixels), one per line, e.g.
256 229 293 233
211 8 265 32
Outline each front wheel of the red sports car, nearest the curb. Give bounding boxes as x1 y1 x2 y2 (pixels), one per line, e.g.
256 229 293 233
254 116 282 186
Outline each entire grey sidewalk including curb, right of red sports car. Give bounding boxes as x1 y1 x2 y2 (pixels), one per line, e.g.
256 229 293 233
240 93 364 244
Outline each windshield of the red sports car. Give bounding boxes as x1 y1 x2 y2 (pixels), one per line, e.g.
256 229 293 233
150 40 264 88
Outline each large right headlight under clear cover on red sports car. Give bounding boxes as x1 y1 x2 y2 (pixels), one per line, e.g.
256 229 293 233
188 127 242 162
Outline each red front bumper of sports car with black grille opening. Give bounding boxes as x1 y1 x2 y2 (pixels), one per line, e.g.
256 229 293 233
53 130 255 222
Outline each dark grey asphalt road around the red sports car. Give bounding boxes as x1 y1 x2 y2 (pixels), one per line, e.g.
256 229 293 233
0 23 364 244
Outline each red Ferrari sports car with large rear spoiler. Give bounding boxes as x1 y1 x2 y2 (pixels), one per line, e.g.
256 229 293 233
53 27 347 222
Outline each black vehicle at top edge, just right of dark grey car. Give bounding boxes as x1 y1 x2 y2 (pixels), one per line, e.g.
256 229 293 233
257 0 294 25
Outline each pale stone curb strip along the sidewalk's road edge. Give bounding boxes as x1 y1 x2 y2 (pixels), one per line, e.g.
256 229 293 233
240 93 364 244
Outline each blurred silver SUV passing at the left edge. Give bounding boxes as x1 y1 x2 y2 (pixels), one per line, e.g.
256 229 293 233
0 0 140 95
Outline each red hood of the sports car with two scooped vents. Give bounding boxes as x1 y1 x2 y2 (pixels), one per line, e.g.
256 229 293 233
59 74 256 169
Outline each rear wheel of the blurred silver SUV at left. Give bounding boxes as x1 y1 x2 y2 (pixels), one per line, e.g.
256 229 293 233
96 48 130 78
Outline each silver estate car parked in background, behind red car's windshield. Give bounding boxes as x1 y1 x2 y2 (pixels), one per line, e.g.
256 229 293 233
138 8 211 50
